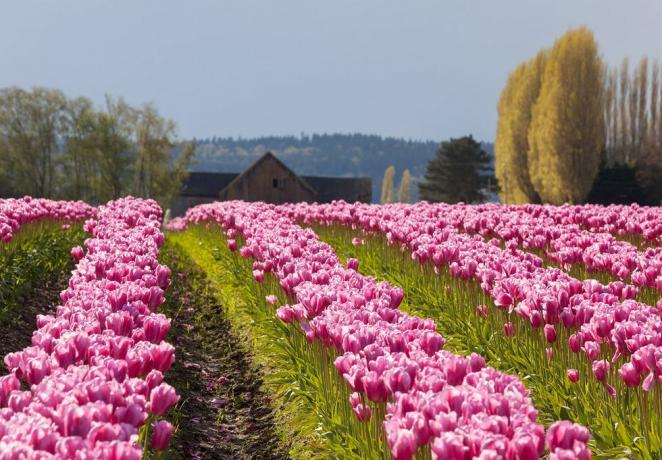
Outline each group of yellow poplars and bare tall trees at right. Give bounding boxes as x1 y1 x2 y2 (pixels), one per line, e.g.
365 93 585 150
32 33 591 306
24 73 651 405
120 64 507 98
495 27 662 204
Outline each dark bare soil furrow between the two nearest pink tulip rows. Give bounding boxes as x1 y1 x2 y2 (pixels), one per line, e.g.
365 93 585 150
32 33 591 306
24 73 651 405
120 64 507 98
161 245 287 459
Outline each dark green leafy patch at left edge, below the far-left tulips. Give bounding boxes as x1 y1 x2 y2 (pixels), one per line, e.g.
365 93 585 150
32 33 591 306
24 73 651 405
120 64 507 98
0 221 86 320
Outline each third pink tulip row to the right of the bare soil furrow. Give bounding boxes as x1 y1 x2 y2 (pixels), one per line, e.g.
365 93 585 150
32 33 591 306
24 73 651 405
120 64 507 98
428 204 662 292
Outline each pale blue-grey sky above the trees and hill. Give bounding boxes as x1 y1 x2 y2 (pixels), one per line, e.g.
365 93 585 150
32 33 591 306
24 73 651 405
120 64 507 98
0 0 662 140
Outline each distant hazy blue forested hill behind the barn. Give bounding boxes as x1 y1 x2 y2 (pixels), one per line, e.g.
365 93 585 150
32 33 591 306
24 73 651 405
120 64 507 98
191 134 492 201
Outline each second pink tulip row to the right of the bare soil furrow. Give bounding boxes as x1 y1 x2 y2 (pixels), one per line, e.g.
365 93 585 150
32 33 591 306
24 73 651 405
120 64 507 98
280 202 662 394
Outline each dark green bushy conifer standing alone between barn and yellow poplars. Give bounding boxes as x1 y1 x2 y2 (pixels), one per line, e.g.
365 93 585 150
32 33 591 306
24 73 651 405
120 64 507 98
419 136 492 203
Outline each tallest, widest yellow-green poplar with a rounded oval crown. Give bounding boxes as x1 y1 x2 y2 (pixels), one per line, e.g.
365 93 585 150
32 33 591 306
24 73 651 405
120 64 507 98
528 27 604 204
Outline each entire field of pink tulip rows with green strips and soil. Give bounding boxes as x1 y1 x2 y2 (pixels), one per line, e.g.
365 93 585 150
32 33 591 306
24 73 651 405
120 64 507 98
0 197 662 460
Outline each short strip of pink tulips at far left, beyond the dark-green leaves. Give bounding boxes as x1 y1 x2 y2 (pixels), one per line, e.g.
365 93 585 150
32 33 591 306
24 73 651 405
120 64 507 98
0 196 95 243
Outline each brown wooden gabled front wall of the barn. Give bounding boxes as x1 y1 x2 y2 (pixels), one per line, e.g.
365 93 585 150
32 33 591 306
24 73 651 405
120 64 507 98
221 158 315 204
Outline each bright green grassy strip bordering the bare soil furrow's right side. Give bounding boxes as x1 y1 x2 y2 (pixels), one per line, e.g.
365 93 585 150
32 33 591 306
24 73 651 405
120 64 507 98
168 226 385 459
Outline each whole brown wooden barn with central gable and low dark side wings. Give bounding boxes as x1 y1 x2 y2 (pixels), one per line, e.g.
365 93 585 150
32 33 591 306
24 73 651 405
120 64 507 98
172 152 372 216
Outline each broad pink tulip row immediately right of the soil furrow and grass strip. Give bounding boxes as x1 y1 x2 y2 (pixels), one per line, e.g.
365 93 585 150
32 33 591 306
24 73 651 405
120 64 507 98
171 202 590 460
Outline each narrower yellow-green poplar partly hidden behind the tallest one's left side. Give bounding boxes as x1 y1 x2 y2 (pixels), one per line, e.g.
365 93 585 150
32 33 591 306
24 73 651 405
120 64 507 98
494 51 546 204
